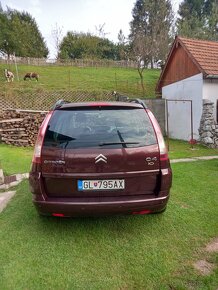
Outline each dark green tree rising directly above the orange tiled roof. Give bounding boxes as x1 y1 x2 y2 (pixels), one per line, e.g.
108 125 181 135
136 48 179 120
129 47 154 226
177 0 218 40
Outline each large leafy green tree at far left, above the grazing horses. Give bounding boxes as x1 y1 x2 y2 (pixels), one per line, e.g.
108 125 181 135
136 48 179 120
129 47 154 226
0 8 48 57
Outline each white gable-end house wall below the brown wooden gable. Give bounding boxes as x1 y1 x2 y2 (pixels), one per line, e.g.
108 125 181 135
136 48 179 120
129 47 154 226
162 73 203 140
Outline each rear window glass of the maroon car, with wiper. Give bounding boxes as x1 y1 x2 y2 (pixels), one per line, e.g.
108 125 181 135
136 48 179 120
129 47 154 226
44 107 157 149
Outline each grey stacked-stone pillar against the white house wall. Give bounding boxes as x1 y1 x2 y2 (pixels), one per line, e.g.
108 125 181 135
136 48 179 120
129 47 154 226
199 100 218 148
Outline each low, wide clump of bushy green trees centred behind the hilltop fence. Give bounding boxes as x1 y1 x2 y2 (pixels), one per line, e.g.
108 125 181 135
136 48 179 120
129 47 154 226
59 32 116 59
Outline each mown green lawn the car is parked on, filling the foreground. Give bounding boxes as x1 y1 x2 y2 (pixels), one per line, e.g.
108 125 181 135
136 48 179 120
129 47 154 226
0 160 218 290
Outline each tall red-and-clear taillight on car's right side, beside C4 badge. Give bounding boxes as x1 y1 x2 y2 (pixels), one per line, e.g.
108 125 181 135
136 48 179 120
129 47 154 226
146 109 169 168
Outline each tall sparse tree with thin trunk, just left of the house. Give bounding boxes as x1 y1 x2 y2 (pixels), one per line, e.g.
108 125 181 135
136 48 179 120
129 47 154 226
129 0 173 93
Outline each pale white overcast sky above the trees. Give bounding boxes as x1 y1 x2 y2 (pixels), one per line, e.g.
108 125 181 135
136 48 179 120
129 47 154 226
0 0 181 57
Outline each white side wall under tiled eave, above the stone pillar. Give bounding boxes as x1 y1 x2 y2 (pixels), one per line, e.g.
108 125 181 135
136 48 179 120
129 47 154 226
203 79 218 120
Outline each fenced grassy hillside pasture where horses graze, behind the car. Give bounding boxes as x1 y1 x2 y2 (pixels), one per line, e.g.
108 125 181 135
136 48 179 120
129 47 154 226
0 64 160 97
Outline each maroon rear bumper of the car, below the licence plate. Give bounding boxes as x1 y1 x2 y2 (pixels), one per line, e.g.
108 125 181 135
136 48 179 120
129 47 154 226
33 193 169 217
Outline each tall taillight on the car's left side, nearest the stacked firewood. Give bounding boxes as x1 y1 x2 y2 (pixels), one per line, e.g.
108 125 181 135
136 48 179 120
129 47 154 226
32 111 53 163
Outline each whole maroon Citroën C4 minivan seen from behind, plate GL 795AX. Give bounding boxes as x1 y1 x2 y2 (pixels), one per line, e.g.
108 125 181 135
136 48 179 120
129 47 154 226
29 100 172 217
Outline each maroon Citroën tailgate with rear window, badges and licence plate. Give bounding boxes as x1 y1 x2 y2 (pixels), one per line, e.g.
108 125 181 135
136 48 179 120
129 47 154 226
41 105 160 198
